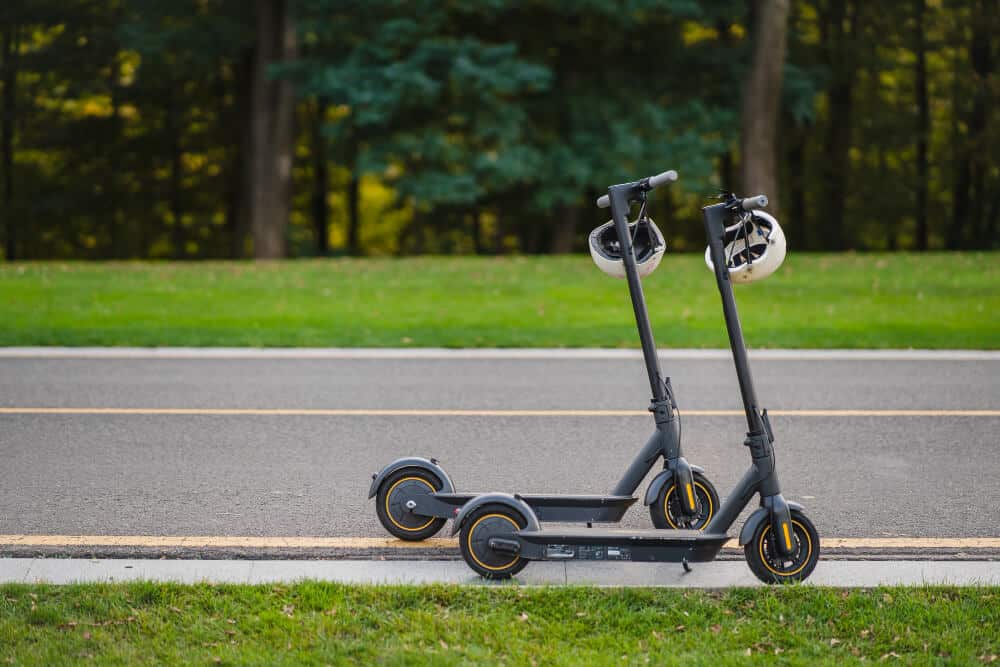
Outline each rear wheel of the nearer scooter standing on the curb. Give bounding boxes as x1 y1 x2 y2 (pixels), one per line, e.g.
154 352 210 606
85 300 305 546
458 504 528 579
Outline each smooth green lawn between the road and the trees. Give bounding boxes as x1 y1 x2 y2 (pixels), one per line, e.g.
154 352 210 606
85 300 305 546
0 253 1000 349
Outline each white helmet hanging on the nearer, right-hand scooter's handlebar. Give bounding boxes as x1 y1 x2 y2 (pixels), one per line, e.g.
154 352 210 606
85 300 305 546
705 211 785 283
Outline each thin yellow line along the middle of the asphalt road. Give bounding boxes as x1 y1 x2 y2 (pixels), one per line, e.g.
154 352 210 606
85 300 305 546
0 407 1000 417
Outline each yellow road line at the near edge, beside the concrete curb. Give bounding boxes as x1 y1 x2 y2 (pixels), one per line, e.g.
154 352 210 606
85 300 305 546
0 535 1000 550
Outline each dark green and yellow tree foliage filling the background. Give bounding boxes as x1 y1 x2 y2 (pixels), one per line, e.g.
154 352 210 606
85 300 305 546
0 0 1000 259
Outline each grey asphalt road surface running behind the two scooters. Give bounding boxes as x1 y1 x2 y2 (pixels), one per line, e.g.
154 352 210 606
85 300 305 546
0 358 1000 537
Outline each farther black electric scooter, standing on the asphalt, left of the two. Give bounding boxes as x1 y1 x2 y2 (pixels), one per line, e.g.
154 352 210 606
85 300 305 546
368 171 719 544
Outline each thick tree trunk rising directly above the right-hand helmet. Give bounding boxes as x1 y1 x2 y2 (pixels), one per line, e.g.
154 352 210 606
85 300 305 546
740 0 789 212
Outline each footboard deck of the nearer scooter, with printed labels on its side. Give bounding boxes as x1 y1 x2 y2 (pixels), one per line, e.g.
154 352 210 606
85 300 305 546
516 528 729 563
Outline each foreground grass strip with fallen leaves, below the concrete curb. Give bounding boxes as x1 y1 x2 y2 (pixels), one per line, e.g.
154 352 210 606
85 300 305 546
0 582 1000 665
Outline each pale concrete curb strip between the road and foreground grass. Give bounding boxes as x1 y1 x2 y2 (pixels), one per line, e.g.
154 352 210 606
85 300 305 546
0 558 1000 588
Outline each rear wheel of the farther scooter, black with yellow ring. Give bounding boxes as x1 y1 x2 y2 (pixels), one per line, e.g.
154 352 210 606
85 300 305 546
375 468 447 542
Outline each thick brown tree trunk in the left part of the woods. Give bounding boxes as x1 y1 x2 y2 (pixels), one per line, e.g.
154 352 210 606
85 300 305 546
250 0 295 259
